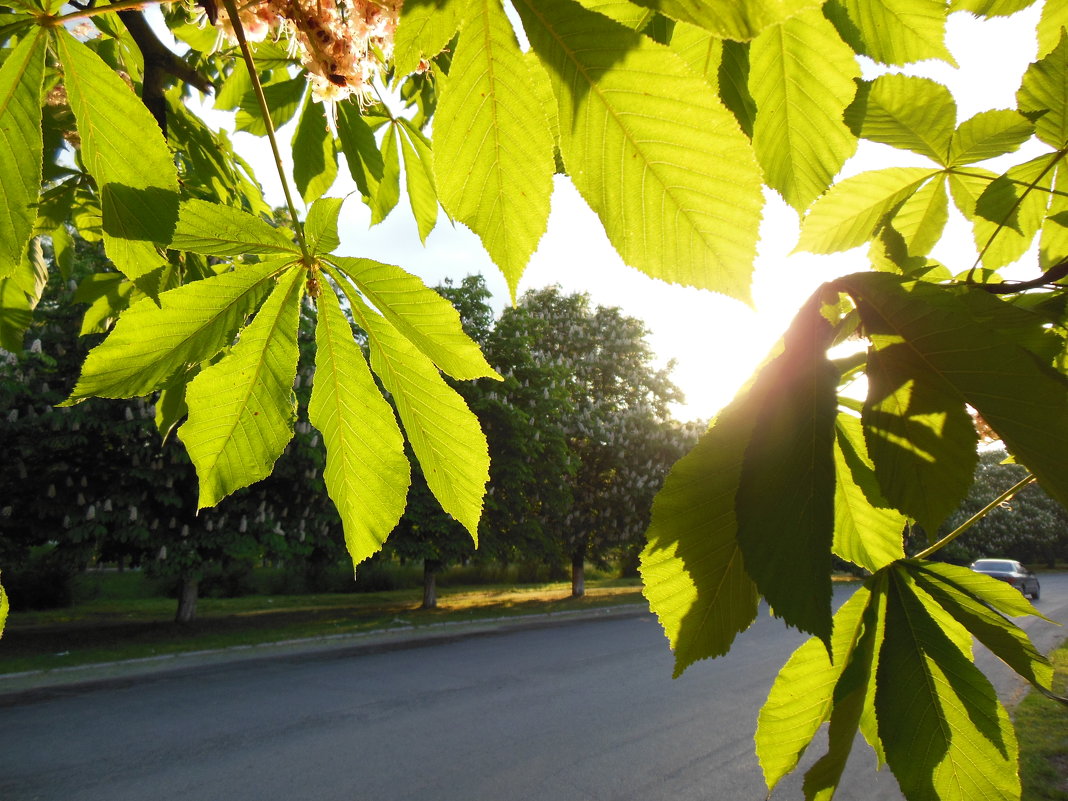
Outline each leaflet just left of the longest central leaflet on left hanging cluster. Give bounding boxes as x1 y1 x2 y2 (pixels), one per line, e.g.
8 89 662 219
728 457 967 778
178 267 304 509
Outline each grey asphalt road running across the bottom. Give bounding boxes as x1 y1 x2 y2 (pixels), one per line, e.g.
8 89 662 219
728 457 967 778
0 576 1068 801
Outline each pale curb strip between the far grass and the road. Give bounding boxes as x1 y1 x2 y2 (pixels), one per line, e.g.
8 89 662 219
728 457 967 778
0 603 649 707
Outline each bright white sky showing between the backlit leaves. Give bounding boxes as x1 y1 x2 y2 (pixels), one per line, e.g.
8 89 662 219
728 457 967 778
227 6 1038 420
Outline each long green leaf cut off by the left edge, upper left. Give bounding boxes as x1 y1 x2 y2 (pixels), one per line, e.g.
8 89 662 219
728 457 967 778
0 30 48 279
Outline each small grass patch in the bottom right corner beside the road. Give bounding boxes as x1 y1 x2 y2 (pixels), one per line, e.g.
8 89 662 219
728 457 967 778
1014 641 1068 801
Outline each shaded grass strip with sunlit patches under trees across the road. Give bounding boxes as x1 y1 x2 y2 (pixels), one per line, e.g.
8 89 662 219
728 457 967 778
0 579 643 675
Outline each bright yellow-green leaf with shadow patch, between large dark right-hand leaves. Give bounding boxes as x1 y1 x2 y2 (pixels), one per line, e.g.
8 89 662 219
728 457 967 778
834 412 907 572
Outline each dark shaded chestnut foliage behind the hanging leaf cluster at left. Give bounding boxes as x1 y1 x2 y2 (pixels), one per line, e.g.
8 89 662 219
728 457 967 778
0 246 344 609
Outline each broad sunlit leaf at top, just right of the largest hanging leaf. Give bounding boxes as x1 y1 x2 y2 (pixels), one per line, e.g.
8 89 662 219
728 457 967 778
749 10 861 211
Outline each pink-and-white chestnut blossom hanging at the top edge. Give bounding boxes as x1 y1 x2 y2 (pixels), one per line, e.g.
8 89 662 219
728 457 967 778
218 0 404 103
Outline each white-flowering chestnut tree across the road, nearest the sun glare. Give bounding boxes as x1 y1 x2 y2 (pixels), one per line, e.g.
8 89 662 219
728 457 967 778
503 286 692 596
